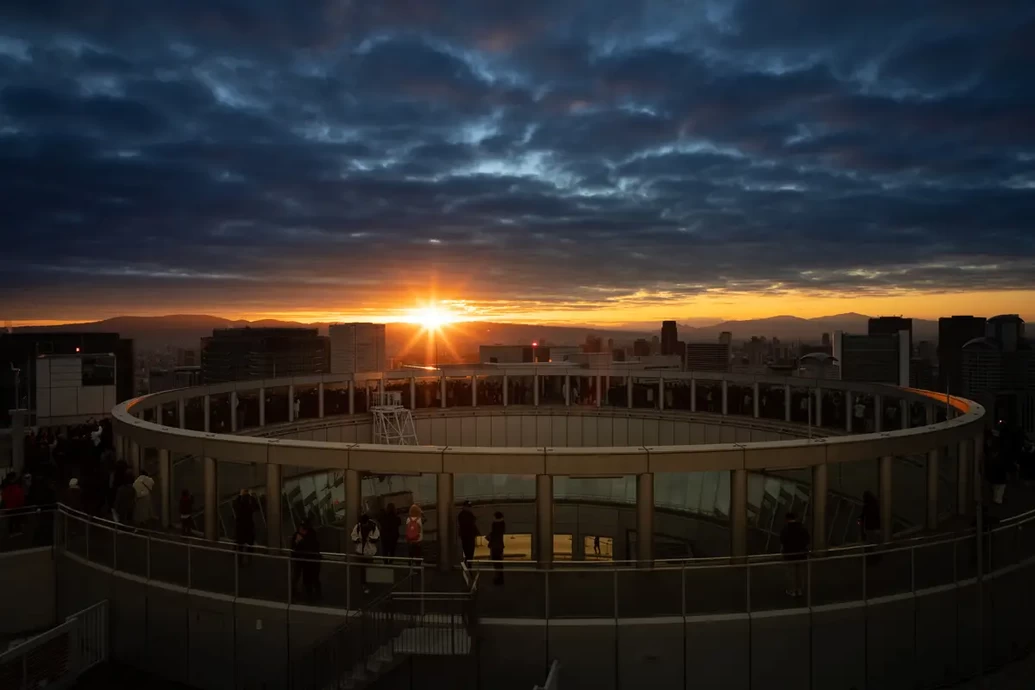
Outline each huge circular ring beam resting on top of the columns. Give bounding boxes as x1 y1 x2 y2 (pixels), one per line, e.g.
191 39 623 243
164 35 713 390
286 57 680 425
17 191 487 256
112 367 984 476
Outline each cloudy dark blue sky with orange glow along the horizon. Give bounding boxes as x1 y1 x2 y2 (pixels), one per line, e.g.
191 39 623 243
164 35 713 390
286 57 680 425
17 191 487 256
0 0 1035 324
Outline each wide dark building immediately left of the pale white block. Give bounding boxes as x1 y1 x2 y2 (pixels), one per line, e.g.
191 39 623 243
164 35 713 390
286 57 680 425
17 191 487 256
201 328 330 384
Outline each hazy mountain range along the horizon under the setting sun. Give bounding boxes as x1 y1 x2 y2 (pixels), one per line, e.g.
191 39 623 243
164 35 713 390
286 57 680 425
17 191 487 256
6 312 938 361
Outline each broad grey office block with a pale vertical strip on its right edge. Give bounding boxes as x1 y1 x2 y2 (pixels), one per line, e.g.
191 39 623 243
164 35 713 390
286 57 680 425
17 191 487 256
832 331 911 386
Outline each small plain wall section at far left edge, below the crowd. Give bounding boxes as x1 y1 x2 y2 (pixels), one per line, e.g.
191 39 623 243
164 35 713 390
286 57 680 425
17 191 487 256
0 546 57 635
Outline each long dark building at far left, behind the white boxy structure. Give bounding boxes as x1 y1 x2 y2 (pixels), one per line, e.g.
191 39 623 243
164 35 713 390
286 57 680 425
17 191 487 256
0 330 136 426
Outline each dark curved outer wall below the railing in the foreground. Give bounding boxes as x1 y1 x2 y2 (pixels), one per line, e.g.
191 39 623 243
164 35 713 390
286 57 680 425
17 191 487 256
52 554 1035 690
